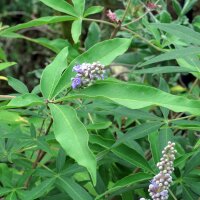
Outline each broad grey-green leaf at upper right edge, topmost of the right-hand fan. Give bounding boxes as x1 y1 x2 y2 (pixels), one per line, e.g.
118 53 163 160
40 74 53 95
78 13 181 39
151 23 200 45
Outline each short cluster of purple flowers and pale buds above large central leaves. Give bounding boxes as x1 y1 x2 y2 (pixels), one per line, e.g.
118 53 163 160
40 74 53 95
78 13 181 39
72 62 105 89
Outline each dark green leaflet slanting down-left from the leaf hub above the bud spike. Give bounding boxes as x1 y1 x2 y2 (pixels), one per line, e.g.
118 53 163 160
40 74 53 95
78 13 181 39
115 122 162 145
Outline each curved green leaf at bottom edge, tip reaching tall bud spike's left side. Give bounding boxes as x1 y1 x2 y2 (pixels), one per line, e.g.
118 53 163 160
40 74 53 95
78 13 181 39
96 173 152 199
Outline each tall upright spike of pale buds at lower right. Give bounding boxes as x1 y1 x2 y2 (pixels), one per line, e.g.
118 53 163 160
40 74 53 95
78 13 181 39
140 142 176 200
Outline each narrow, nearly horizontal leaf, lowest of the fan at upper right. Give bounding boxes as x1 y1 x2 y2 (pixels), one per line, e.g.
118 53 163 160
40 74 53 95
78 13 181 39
133 66 195 74
